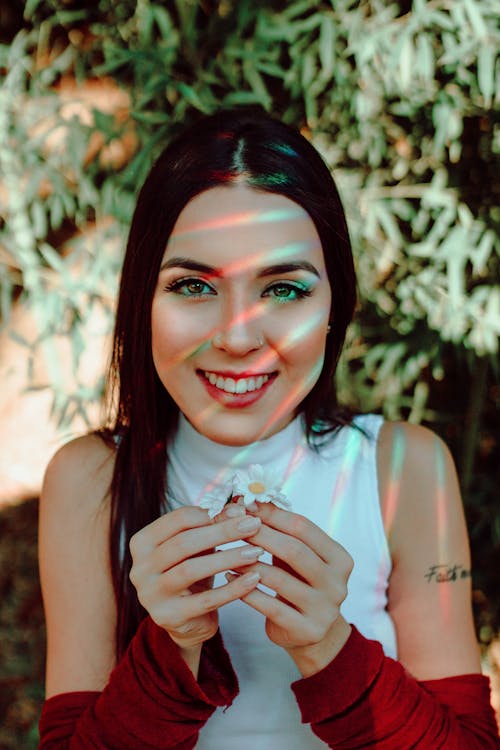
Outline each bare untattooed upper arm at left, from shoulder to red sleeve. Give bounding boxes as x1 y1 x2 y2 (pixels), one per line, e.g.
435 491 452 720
38 434 116 697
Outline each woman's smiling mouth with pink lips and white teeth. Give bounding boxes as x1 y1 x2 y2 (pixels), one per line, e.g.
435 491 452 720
197 370 278 408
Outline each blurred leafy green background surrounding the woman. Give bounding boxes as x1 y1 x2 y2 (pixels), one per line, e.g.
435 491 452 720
0 0 500 750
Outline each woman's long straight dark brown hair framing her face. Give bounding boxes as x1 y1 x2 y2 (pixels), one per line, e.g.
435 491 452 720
101 107 356 658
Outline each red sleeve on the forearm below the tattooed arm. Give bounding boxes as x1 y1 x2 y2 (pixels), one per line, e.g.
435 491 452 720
292 626 500 750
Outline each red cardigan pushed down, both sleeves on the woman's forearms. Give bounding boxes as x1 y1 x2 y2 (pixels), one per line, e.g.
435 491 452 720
39 617 500 750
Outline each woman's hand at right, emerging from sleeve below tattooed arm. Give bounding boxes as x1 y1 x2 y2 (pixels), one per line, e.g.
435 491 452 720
229 503 353 676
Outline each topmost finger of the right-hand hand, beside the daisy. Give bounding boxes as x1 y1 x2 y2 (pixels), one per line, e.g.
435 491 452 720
248 503 334 562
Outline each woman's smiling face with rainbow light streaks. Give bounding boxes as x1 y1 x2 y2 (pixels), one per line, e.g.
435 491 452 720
151 183 331 446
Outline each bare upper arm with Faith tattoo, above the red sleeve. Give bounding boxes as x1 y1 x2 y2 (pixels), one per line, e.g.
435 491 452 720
378 423 481 680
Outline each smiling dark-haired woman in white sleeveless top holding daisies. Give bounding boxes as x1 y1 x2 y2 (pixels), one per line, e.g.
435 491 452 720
40 108 498 750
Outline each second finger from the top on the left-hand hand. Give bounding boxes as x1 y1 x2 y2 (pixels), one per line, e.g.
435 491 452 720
149 516 262 572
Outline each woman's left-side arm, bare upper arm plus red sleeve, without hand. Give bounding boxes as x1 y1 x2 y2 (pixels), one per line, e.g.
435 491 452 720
39 437 237 750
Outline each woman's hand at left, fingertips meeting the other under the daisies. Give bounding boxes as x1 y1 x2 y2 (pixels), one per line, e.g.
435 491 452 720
130 506 263 649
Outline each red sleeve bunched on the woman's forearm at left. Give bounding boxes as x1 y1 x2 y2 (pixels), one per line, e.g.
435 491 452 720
39 617 238 750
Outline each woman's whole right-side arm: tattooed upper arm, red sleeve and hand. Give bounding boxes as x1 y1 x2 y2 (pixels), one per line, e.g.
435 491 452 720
235 424 498 750
